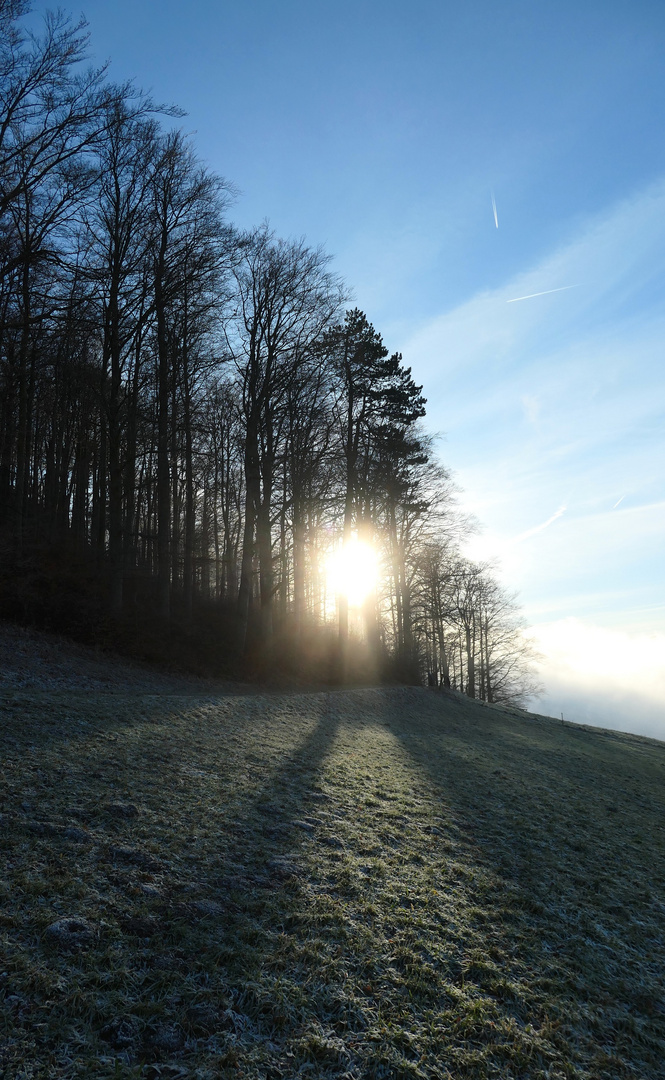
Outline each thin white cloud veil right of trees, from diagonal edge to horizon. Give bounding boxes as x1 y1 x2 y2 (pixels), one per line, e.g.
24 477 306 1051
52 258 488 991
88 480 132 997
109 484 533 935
404 181 665 734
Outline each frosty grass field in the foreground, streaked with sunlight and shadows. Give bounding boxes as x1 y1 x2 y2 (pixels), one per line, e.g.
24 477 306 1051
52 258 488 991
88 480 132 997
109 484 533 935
0 689 665 1080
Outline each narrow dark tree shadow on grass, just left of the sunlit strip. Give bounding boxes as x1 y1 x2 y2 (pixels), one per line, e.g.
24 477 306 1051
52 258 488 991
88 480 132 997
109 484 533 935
142 694 347 1054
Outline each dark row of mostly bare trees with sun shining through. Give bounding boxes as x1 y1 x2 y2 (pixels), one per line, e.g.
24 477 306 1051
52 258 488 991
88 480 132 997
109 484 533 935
0 0 539 701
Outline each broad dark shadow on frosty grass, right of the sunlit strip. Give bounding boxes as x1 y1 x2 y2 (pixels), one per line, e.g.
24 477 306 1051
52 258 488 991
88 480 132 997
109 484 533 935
383 690 665 1076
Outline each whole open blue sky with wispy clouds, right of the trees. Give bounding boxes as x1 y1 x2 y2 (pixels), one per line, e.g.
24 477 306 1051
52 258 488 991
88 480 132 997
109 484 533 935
29 0 665 738
